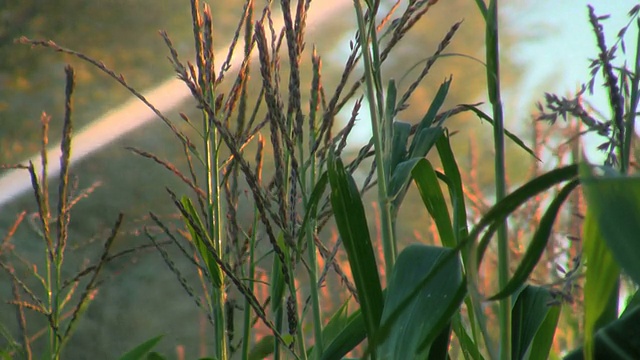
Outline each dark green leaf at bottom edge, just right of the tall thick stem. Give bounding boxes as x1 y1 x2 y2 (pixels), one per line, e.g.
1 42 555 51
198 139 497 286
511 285 560 360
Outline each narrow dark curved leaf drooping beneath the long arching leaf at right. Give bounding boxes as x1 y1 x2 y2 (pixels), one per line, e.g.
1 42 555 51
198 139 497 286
489 180 579 300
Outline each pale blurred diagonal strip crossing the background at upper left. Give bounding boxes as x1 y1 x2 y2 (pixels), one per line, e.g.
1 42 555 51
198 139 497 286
0 0 352 208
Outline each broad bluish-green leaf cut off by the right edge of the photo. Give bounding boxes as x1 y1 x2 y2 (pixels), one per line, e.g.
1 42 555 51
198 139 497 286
580 165 640 284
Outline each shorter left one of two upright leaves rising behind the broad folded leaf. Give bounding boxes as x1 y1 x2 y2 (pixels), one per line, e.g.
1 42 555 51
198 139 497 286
411 159 456 247
